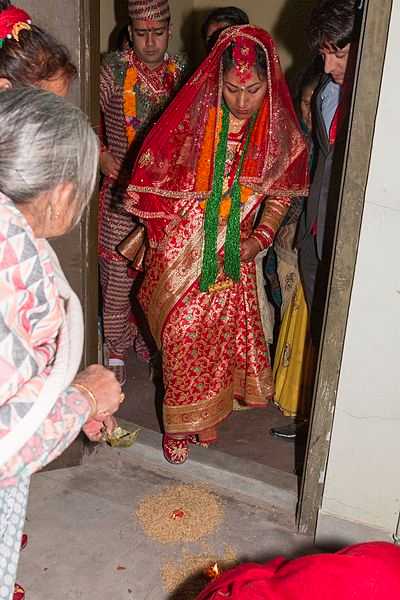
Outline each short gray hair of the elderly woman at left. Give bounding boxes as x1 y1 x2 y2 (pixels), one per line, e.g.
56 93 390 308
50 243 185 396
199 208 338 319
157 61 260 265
0 88 99 222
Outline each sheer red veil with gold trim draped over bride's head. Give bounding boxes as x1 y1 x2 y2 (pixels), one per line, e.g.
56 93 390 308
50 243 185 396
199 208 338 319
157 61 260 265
126 25 308 228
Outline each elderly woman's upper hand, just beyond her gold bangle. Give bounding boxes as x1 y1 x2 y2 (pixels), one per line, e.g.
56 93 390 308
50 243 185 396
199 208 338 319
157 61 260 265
72 365 123 423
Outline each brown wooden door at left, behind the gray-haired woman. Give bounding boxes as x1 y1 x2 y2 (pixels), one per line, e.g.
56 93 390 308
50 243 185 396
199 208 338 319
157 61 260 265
19 0 101 366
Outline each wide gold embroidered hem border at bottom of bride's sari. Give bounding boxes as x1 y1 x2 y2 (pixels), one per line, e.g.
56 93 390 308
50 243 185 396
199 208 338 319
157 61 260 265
163 386 233 434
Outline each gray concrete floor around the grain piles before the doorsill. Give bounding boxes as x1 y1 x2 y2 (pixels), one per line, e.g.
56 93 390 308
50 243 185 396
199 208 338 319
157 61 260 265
18 448 312 600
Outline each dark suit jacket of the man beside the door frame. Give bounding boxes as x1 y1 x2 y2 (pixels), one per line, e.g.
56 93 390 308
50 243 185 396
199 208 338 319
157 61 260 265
297 75 335 260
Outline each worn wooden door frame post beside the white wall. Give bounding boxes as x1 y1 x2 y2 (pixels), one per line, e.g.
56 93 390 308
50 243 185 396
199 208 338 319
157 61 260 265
297 0 392 535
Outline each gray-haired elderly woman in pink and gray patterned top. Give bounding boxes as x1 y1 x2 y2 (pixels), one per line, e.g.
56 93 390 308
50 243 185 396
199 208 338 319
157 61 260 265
0 88 122 600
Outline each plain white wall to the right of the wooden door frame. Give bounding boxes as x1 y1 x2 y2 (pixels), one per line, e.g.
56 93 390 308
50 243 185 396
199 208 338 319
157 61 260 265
321 2 400 533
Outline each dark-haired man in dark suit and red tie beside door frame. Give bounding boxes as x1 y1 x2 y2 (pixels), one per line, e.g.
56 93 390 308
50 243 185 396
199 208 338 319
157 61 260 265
271 0 362 439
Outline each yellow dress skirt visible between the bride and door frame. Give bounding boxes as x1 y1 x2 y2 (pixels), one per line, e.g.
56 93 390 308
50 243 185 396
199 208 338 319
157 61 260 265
273 282 312 417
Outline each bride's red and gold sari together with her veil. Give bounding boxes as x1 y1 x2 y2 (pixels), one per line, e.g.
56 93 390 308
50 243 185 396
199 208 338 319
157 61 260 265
126 26 307 434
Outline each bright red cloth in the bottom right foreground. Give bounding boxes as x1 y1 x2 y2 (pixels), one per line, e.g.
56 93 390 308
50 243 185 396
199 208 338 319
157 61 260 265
197 542 400 600
